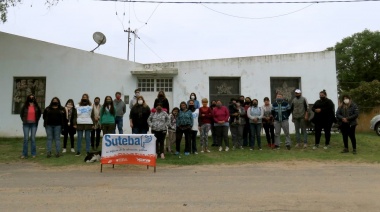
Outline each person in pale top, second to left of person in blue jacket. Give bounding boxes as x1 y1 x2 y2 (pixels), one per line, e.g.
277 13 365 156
247 99 264 150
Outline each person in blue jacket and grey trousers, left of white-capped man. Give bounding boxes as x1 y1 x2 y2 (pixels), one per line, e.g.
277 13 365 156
271 93 291 150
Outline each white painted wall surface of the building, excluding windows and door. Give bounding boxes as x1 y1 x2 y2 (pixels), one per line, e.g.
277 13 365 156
0 32 337 137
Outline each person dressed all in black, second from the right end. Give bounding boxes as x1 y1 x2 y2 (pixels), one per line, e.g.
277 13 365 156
312 90 336 149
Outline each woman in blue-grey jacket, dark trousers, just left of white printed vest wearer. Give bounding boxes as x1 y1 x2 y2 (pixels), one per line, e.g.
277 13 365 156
175 102 194 156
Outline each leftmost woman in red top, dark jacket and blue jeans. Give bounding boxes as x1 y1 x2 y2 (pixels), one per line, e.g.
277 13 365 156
20 94 41 159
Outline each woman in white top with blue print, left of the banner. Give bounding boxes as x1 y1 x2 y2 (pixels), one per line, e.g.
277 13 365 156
75 94 94 156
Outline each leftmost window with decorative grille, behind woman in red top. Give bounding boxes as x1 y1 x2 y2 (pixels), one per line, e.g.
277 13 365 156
12 77 46 114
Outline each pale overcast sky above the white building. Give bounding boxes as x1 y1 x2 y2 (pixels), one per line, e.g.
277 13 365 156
0 0 380 63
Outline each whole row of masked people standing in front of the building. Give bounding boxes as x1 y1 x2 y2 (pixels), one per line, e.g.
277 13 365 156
20 89 358 159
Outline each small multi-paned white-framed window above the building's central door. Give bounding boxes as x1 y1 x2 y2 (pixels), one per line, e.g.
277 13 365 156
138 78 173 92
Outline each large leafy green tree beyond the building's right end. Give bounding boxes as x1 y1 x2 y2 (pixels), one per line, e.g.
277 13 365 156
327 29 380 93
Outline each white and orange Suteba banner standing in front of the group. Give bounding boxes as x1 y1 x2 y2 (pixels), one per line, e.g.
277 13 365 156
100 134 156 166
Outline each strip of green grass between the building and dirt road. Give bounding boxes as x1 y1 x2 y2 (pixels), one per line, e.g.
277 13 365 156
0 132 380 166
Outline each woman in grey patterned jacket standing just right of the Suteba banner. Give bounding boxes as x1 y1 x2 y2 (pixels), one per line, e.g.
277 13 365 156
148 103 170 159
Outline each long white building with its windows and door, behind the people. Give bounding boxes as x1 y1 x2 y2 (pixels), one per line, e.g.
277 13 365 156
0 32 337 137
